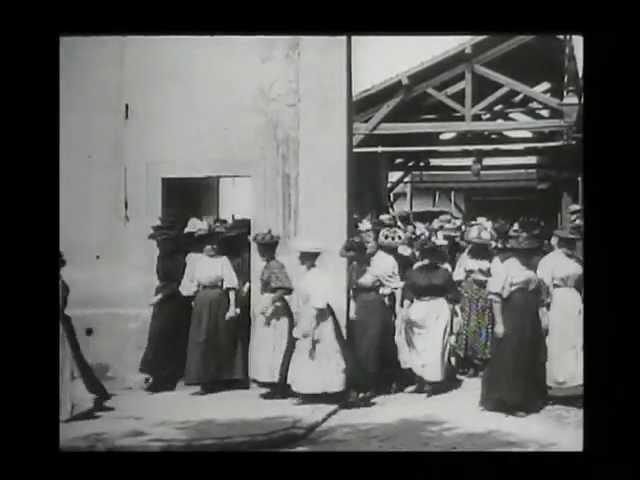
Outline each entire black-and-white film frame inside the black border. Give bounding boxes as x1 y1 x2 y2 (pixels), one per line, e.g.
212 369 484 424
60 32 593 452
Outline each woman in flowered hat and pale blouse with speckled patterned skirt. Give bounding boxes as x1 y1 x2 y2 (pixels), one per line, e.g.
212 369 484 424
453 224 494 377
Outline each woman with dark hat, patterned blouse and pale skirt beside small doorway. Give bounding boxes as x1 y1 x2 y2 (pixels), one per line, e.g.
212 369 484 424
249 230 294 398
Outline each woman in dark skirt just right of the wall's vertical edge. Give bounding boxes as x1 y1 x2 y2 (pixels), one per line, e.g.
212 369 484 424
341 237 392 404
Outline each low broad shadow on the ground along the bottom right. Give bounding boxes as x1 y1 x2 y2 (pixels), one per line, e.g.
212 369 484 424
286 419 557 451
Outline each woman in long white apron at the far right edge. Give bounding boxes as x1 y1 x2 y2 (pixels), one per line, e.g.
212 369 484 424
538 223 583 400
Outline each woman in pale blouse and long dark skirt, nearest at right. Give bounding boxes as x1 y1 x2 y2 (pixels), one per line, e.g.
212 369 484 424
480 234 548 416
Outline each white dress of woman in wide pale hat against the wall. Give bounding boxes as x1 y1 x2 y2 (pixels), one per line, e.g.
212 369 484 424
288 268 346 394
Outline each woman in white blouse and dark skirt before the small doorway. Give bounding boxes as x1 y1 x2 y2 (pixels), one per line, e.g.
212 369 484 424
185 235 244 395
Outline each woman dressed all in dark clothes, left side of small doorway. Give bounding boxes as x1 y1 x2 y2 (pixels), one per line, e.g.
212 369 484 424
140 222 191 393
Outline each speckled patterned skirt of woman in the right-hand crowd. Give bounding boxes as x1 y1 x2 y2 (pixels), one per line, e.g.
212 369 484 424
455 280 494 363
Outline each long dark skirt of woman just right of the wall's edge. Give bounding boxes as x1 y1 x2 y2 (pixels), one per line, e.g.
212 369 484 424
347 263 392 392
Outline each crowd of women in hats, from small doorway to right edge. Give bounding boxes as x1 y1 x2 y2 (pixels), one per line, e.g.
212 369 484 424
60 206 583 416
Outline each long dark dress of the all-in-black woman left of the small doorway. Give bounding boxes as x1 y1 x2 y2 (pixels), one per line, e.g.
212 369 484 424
140 252 191 387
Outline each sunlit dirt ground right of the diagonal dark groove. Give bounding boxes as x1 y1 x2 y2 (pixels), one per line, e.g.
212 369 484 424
286 378 583 451
